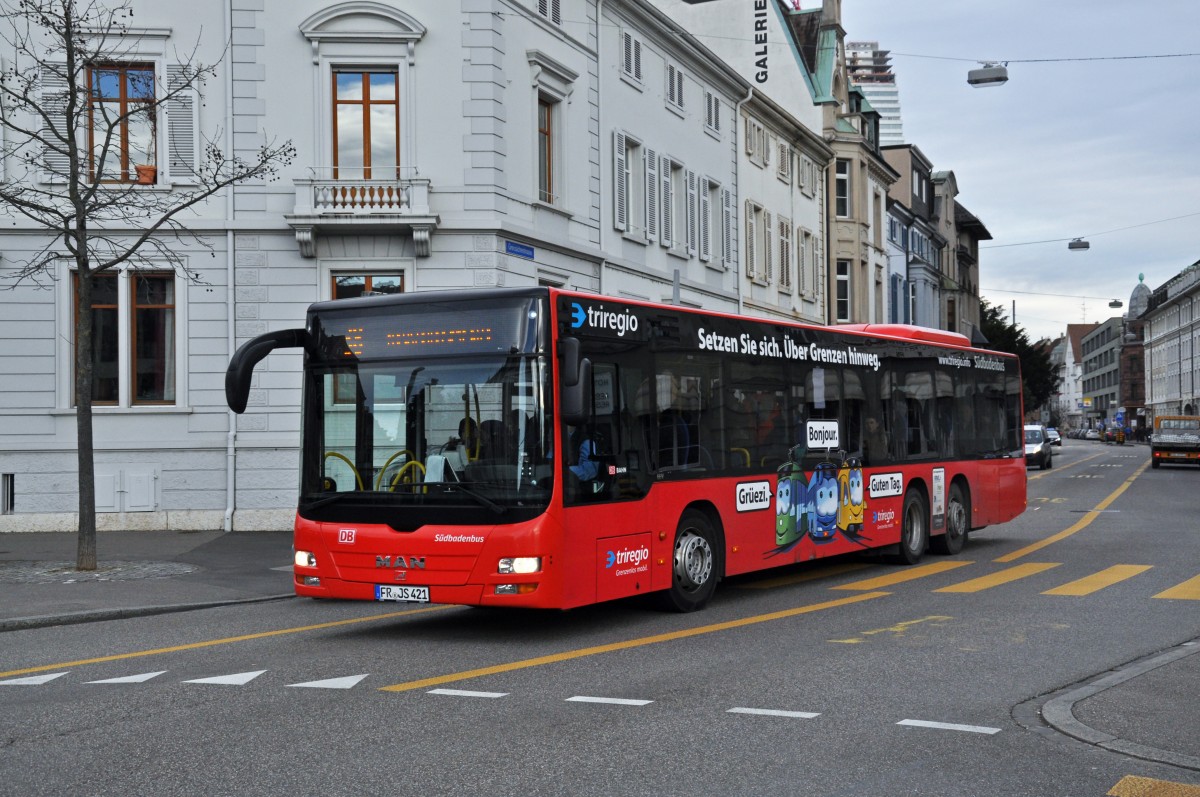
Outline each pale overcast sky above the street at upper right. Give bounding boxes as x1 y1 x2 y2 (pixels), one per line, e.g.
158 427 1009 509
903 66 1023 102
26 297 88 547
835 0 1200 340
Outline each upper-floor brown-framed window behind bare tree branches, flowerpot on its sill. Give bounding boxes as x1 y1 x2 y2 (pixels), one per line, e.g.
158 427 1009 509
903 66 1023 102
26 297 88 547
88 64 157 182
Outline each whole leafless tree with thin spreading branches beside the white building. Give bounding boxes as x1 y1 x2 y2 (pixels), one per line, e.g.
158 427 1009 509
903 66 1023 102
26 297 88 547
0 0 295 570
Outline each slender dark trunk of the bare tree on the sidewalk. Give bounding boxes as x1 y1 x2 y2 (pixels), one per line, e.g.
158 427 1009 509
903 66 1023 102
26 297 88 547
74 264 96 570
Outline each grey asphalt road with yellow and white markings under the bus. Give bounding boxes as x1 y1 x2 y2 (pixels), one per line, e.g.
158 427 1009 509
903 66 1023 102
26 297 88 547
0 441 1200 797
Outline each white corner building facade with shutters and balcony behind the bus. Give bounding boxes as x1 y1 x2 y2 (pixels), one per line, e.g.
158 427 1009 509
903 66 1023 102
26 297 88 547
0 0 828 532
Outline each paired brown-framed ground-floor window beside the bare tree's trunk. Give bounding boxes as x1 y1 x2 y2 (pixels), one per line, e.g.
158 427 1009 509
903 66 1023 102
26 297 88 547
72 271 176 406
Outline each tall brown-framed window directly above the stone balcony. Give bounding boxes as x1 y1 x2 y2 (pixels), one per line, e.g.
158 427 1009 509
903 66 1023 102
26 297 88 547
334 70 400 180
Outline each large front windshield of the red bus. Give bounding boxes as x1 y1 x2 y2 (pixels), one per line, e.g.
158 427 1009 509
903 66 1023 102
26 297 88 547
300 355 552 513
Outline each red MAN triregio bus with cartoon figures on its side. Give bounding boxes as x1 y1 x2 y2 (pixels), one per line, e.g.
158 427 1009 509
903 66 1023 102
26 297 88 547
226 287 1026 611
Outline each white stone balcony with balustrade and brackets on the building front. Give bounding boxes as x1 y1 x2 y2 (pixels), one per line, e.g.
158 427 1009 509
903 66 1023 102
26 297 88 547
287 169 438 257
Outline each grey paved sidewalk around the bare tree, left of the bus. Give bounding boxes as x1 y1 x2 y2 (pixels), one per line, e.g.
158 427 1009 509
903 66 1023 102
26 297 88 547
0 531 294 633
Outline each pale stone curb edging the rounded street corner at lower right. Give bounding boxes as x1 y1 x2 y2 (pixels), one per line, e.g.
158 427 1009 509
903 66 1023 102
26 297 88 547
1040 641 1200 772
